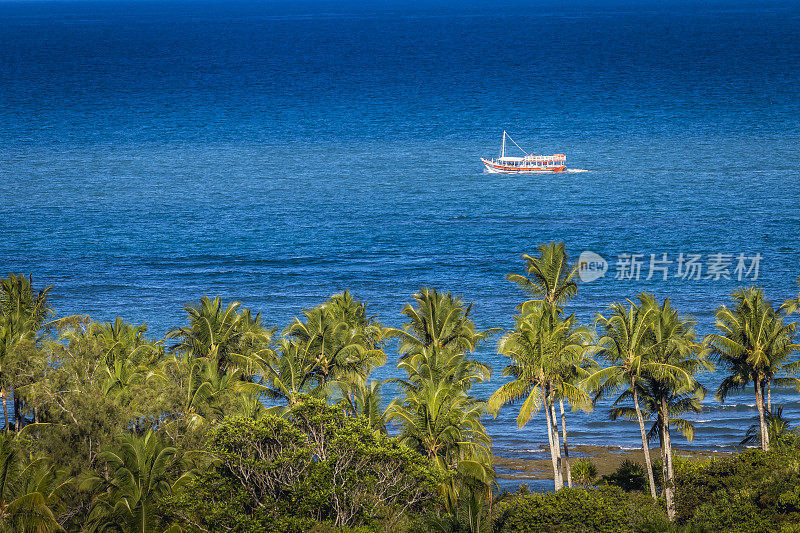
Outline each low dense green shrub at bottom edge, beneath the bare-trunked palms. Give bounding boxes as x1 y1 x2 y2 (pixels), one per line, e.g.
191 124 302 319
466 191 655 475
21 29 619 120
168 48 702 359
496 486 667 533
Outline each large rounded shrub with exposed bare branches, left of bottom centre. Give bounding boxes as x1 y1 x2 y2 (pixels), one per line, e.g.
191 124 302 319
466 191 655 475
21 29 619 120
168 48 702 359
159 397 441 532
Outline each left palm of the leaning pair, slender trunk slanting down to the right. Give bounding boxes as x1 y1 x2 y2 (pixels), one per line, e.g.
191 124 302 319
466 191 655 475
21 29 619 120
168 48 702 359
585 296 667 499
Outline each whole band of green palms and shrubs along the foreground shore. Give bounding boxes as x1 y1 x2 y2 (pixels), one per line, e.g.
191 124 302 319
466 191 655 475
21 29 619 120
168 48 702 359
0 243 800 533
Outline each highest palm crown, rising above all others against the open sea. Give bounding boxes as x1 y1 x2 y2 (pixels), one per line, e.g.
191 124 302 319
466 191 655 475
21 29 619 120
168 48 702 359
506 242 578 305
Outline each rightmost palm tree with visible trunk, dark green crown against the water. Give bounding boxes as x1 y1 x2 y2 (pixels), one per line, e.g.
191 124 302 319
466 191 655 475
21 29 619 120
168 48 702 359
706 287 800 450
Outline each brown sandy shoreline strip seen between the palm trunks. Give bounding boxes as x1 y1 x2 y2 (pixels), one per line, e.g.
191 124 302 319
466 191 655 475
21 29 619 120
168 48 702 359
494 445 732 481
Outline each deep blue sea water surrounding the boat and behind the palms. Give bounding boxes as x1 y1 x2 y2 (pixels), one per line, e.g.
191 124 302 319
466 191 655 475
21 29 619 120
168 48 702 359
0 0 800 490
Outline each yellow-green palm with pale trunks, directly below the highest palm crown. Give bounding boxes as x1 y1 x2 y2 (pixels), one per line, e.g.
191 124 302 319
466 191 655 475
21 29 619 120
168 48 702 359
488 302 590 490
